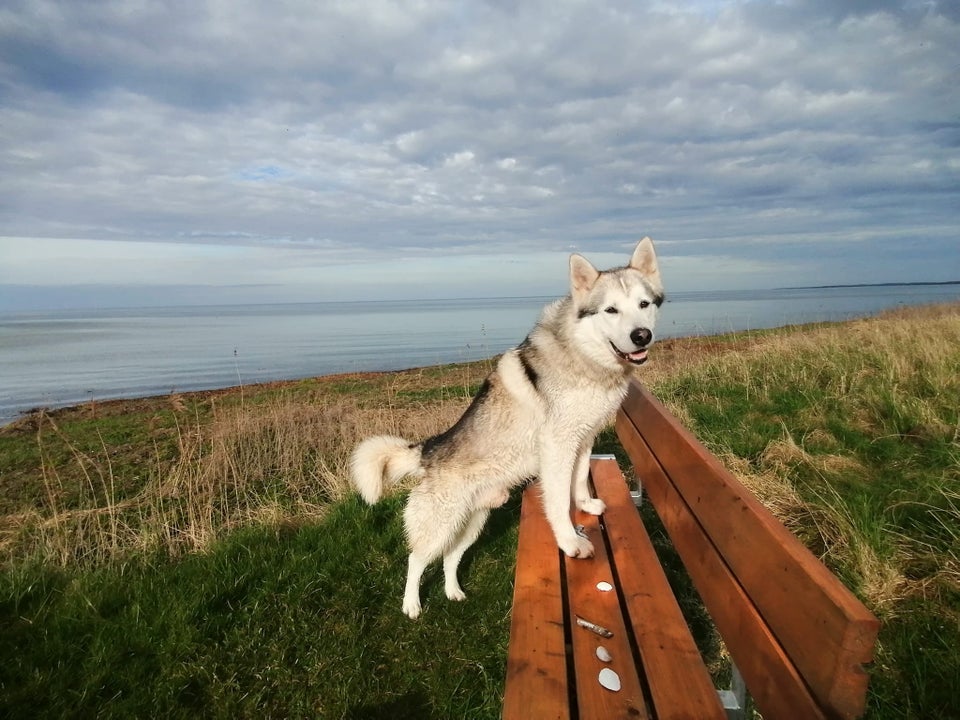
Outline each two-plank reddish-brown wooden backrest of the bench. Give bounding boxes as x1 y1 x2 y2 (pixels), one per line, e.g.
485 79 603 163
616 382 879 718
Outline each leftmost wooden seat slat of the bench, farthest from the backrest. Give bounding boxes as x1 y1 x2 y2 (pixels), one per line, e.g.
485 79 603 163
503 486 570 720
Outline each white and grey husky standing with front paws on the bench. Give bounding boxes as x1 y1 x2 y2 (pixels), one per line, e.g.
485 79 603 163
350 238 663 618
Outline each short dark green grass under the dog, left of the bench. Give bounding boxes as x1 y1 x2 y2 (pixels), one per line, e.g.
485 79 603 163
0 498 518 719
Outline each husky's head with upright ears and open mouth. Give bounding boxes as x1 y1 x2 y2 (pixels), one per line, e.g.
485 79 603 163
570 237 664 366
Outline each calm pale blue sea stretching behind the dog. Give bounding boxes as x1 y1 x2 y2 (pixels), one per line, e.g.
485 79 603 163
0 285 960 424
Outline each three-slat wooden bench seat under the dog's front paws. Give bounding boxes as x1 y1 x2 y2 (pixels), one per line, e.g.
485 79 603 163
503 458 725 720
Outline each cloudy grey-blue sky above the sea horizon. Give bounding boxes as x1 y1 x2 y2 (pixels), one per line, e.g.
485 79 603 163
0 0 960 310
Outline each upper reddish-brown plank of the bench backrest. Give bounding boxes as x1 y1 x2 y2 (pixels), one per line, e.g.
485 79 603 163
622 383 879 717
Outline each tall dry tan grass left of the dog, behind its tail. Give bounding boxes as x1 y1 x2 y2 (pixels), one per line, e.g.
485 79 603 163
0 368 484 567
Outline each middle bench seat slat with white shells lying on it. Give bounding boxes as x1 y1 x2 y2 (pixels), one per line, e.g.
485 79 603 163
568 470 649 720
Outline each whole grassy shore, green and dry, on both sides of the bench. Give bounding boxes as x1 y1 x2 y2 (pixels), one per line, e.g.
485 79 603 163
0 305 960 718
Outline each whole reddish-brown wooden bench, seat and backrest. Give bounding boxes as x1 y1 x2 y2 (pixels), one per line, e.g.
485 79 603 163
503 383 879 720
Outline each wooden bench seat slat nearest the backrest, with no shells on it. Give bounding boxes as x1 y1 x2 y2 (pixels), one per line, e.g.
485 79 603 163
591 460 726 720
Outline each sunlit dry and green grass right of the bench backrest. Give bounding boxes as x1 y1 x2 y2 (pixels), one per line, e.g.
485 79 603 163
654 305 960 617
